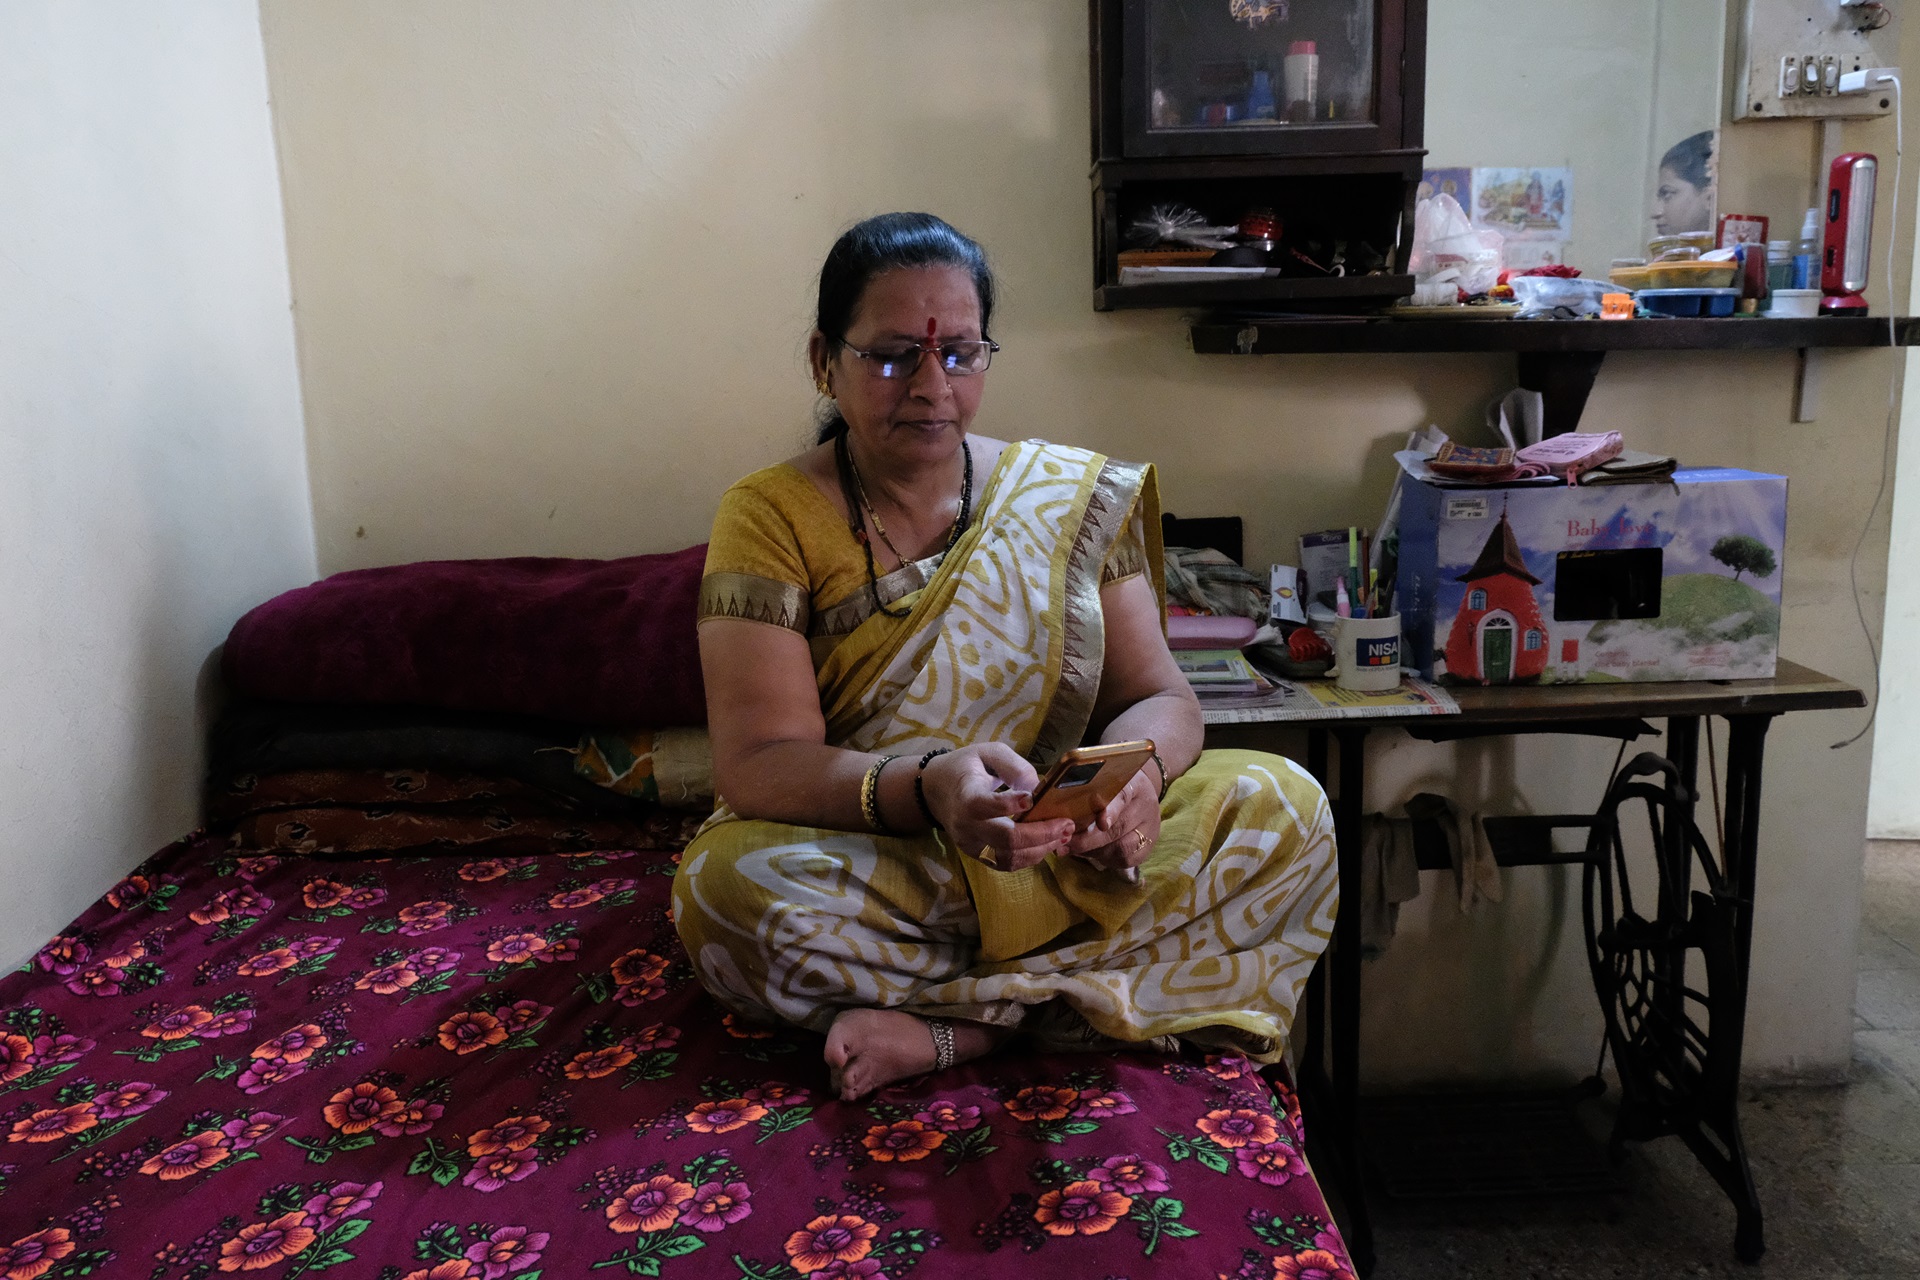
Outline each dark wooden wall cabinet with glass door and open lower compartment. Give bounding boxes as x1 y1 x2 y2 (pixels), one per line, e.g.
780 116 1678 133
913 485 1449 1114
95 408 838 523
1091 0 1427 311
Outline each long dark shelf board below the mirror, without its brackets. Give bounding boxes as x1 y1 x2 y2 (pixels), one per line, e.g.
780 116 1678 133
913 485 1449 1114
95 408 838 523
1192 317 1920 355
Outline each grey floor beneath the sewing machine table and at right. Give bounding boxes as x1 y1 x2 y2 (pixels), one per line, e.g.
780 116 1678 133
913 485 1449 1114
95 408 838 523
1373 841 1920 1280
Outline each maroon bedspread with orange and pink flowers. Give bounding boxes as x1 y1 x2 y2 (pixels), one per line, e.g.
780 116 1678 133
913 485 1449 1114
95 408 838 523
0 837 1352 1280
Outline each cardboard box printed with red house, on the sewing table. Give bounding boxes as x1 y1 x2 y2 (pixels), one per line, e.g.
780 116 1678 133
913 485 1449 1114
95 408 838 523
1396 468 1788 685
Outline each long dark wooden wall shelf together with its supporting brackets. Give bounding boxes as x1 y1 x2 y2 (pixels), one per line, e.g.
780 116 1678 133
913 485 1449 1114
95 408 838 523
1192 317 1920 436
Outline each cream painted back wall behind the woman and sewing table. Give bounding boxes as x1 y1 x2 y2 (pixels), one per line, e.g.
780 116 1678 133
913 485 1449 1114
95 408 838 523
263 0 1907 1082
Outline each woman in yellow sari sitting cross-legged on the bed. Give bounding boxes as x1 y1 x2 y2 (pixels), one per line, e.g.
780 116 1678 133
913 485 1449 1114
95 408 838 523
674 213 1336 1100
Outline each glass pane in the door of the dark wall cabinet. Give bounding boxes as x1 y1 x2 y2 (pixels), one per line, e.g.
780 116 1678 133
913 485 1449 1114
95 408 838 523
1129 0 1380 155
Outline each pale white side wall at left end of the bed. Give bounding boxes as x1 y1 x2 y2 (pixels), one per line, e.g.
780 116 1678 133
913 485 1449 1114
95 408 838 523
0 0 315 967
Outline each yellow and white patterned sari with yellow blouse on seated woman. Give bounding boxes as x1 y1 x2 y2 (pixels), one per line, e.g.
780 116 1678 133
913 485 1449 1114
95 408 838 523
674 441 1336 1061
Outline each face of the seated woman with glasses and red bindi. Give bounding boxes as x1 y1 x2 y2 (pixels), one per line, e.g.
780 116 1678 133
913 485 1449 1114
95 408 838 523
808 267 985 464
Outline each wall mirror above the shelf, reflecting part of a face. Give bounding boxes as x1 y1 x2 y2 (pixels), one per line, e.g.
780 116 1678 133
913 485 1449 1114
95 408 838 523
1427 0 1726 274
